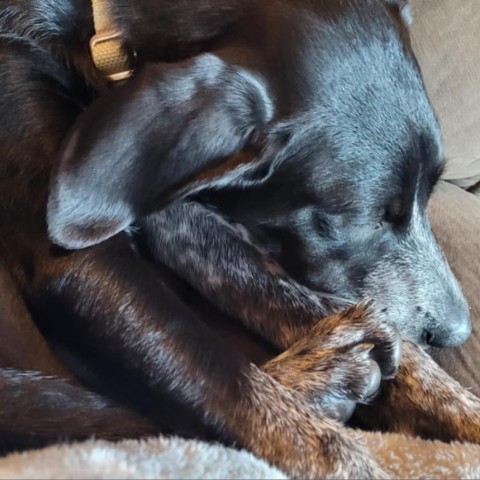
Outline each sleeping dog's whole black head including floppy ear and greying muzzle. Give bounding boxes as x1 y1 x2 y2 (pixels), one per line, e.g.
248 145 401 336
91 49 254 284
49 1 470 346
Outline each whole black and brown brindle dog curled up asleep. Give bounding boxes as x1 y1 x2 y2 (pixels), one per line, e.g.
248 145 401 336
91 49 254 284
0 0 479 478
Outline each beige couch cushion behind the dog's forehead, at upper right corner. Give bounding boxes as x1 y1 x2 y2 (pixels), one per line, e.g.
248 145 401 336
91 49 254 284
410 0 480 188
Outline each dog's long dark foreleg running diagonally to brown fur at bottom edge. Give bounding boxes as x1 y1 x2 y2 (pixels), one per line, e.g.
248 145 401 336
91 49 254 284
31 235 383 478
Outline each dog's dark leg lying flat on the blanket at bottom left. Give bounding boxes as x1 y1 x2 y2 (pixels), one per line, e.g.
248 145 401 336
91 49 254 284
0 368 158 453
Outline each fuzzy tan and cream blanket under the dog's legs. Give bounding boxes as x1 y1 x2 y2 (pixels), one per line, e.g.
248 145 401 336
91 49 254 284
0 433 480 479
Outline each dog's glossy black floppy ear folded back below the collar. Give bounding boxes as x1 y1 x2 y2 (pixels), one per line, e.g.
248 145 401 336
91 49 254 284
47 54 273 249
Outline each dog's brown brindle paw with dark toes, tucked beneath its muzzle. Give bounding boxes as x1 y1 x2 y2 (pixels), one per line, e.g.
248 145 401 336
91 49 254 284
265 305 401 422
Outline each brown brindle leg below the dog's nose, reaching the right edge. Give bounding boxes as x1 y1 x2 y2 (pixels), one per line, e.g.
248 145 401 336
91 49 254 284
358 340 480 443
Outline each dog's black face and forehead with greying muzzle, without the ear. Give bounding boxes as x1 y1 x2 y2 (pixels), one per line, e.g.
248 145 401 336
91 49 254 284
197 2 471 346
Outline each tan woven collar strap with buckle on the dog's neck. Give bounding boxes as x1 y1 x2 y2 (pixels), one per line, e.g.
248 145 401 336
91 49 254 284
90 0 135 82
